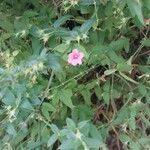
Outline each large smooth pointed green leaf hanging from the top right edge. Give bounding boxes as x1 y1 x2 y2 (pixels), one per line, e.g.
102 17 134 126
126 0 144 25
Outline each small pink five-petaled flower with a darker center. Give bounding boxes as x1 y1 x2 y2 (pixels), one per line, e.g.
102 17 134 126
68 49 84 66
